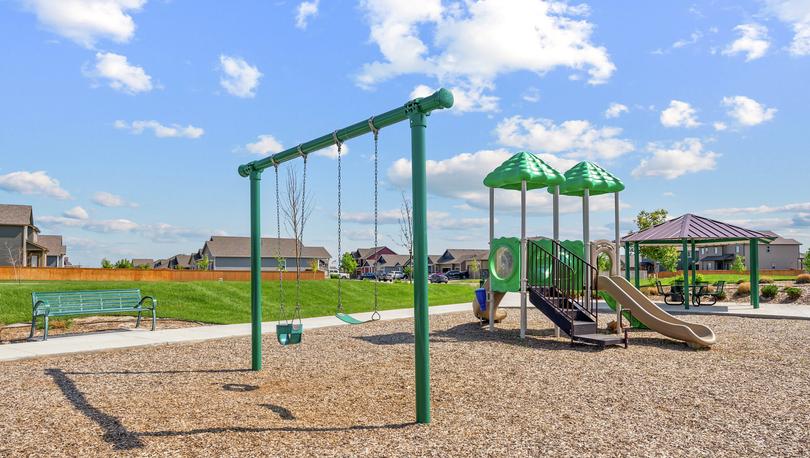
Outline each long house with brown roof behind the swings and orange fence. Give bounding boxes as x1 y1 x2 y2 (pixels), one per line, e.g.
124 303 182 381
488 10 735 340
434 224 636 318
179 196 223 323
199 235 331 272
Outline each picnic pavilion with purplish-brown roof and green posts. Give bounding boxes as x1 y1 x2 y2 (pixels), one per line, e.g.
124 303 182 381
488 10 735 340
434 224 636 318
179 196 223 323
622 213 776 309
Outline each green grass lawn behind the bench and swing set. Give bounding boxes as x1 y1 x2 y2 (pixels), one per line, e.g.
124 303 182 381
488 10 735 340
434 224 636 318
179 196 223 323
0 280 477 324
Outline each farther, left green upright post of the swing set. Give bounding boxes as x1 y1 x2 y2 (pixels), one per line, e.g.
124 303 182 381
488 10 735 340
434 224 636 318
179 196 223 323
250 170 262 371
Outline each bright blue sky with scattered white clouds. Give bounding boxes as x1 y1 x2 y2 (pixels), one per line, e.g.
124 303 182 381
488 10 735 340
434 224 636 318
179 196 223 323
0 0 810 266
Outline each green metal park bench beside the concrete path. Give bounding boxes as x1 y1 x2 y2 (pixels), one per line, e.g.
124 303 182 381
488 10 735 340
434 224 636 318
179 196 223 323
29 289 157 340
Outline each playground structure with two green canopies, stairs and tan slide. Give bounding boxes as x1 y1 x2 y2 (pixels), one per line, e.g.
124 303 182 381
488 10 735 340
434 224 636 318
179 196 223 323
476 152 716 347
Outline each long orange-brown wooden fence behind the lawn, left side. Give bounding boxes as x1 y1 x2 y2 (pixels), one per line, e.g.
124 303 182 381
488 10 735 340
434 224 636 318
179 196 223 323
0 267 326 281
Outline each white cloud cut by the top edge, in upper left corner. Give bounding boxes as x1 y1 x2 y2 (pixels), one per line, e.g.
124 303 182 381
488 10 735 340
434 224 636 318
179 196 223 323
24 0 146 48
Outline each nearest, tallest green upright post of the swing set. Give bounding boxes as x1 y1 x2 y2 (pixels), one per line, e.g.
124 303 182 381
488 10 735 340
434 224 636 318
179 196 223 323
410 110 430 423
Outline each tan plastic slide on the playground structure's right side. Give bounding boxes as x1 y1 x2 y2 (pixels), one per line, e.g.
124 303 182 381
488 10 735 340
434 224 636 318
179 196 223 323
599 275 716 347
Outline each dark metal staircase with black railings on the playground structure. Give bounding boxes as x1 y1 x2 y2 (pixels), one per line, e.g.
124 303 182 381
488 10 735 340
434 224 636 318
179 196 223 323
526 240 626 346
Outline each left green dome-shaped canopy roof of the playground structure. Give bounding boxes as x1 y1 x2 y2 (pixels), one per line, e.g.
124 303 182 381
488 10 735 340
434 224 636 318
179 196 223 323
484 151 565 191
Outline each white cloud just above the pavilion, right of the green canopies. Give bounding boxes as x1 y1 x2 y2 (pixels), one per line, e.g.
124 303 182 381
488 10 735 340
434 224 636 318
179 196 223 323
633 138 720 180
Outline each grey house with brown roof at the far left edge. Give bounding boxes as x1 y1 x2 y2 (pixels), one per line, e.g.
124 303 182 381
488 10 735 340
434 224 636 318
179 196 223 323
0 204 67 267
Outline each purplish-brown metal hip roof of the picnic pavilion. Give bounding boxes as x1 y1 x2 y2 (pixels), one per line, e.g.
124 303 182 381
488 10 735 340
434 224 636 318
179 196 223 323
622 213 776 244
